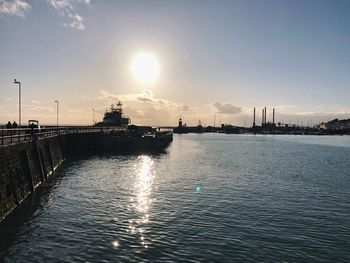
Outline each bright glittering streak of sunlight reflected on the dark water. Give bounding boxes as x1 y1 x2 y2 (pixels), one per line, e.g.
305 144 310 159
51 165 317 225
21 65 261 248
127 155 155 248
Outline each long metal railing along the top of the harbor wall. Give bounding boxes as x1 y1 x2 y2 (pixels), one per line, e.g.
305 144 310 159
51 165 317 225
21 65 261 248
0 127 104 145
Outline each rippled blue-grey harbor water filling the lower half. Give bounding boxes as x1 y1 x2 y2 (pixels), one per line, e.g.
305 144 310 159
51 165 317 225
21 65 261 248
0 134 350 262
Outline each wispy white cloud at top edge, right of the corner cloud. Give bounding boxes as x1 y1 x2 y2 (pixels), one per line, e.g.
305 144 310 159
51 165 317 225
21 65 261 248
48 0 91 30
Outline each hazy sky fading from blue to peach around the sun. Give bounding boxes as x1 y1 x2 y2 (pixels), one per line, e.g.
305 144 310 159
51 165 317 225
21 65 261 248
0 0 350 126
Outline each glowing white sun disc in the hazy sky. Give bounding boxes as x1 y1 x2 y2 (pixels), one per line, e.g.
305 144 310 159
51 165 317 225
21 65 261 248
130 52 160 85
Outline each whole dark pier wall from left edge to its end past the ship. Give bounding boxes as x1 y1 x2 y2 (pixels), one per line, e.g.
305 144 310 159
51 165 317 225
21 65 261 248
0 129 173 222
